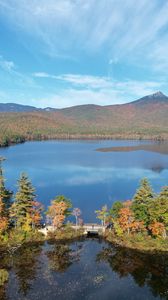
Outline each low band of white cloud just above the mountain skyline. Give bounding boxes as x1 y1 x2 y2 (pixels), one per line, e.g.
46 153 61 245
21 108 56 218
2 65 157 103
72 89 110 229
1 59 166 108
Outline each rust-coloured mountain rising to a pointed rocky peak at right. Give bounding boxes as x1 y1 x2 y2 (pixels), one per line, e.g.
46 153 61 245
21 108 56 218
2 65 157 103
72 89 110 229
56 92 168 124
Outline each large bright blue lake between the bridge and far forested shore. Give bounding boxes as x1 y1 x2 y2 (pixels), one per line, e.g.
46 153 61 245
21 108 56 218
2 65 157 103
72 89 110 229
0 141 168 222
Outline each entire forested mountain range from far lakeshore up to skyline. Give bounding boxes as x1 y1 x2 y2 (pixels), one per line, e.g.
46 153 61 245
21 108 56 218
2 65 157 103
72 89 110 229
0 92 168 146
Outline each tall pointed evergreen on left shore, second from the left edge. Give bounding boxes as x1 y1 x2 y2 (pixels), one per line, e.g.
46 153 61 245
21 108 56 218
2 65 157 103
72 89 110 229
11 173 35 228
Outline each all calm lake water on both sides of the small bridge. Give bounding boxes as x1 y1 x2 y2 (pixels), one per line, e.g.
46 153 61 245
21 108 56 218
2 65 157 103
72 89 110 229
0 141 168 300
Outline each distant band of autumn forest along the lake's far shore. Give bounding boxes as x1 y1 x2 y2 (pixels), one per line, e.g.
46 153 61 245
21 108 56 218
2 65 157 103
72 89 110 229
0 112 168 146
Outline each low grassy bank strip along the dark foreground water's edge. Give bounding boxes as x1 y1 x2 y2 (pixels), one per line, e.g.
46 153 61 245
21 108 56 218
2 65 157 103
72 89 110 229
0 227 168 255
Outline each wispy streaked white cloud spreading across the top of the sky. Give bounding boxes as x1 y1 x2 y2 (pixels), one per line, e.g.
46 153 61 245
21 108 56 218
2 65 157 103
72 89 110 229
0 0 168 68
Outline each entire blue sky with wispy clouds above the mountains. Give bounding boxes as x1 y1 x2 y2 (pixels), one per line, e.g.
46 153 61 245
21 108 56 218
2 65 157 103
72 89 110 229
0 0 168 108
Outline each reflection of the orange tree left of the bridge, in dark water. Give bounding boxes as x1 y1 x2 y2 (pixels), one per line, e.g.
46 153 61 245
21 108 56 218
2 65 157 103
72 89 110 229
47 244 80 272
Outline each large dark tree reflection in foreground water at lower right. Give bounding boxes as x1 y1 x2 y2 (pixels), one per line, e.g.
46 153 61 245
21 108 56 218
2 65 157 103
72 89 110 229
97 246 168 299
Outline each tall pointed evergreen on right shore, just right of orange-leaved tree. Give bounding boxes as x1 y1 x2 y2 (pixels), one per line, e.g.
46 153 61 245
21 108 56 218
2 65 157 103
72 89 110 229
132 178 154 226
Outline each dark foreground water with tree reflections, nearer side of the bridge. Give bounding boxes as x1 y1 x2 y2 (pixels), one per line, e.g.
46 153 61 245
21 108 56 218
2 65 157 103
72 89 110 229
0 239 168 300
